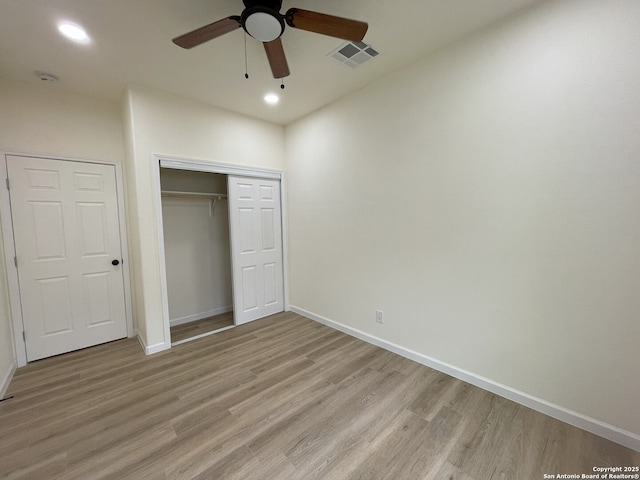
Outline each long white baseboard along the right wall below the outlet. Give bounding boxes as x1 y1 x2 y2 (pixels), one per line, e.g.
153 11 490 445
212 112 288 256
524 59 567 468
291 305 640 452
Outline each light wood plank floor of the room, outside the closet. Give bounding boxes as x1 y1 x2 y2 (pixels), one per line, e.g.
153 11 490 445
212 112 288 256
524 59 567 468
0 313 640 480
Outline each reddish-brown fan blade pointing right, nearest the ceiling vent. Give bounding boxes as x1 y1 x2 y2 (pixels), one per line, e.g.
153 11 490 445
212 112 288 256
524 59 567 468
285 8 369 42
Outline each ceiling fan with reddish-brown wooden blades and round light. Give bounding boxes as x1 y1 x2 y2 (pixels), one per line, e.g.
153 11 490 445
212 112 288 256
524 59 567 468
173 0 368 78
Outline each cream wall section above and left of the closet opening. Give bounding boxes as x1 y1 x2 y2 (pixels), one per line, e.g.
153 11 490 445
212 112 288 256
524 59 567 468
123 86 284 348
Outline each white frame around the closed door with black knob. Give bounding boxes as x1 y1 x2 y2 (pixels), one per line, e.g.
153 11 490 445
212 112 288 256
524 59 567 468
0 152 135 367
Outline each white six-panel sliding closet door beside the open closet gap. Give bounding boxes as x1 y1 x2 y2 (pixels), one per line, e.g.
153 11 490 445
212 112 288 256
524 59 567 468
228 175 284 325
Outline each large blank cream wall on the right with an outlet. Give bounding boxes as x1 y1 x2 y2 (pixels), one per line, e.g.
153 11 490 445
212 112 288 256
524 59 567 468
286 0 640 435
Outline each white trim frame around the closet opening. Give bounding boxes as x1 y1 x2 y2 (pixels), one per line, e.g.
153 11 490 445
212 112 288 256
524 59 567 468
151 154 289 351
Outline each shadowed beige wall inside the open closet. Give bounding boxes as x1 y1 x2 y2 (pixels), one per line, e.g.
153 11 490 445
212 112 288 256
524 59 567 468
160 168 233 326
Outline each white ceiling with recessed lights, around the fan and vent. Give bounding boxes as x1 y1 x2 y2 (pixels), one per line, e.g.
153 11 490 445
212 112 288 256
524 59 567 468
0 0 539 124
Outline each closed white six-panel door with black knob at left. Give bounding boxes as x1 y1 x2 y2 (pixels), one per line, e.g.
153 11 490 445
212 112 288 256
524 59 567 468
7 156 127 361
